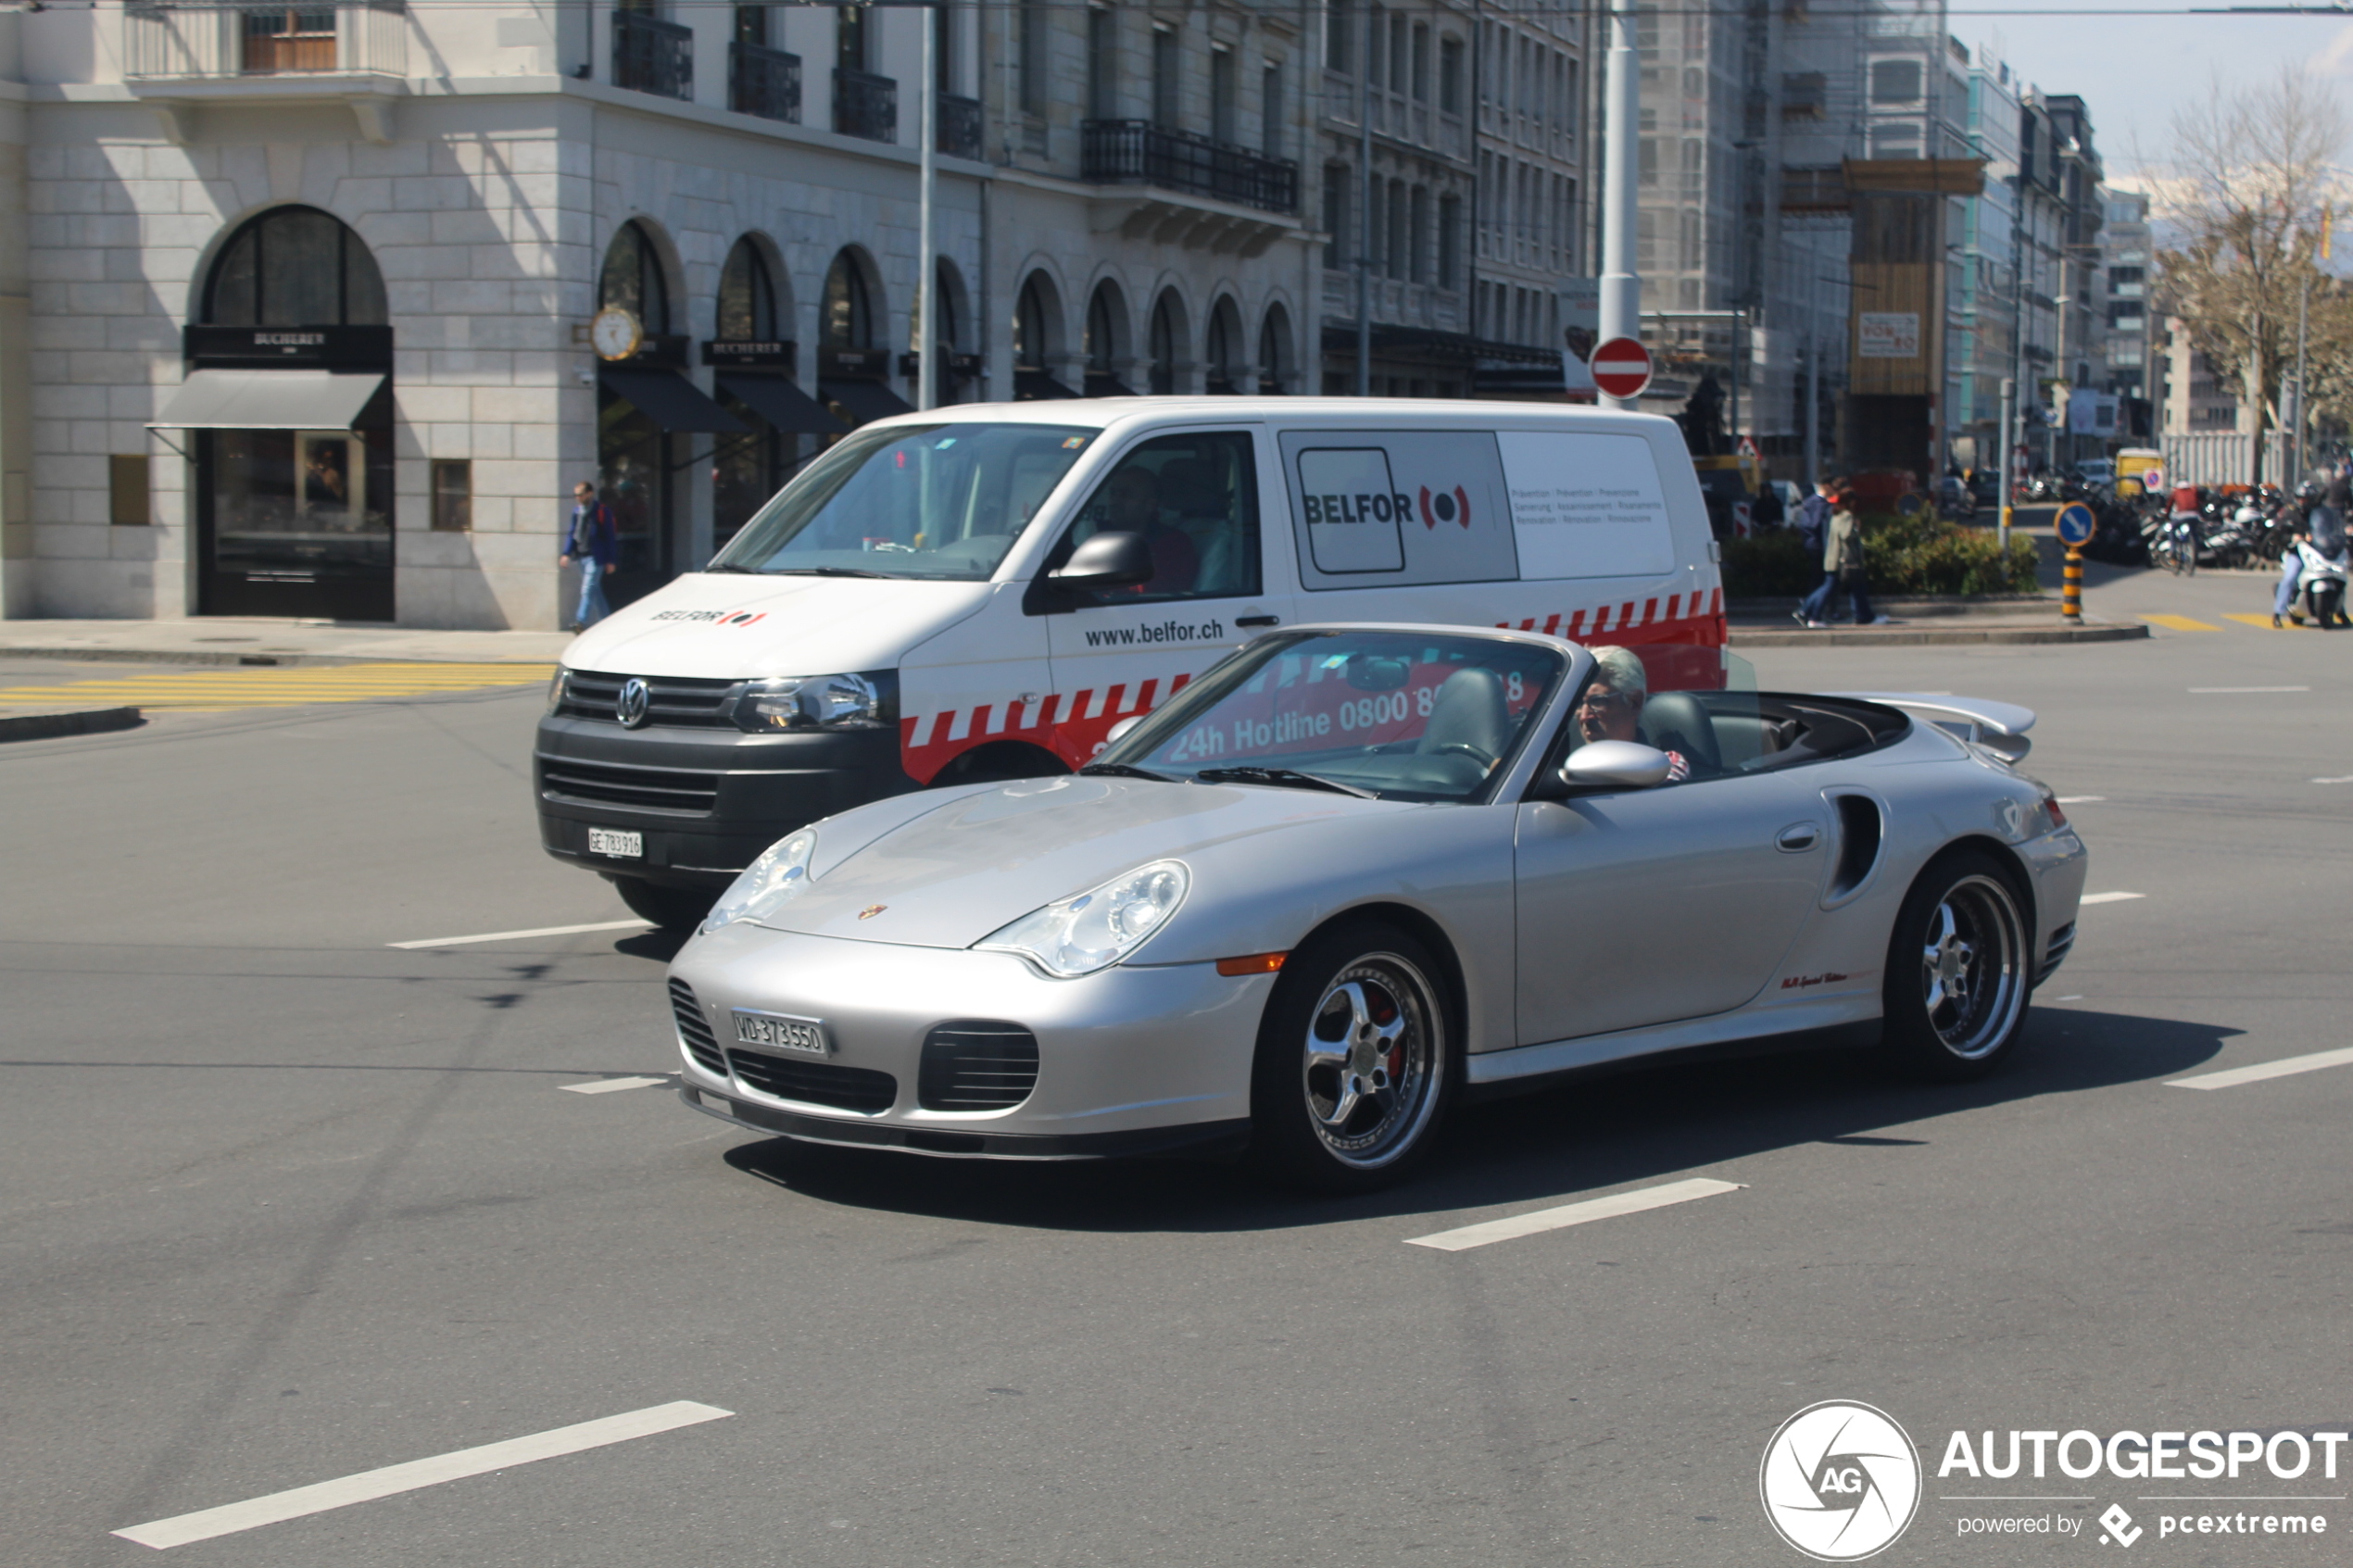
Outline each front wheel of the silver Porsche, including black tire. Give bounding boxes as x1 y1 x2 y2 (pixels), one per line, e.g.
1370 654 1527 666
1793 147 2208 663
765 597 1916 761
1250 922 1456 1192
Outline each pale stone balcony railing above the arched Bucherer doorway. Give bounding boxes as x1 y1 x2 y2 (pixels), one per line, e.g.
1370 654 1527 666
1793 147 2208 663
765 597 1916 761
122 0 409 82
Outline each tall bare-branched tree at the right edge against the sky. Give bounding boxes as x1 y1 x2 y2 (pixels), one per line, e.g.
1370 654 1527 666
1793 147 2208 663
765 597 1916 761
2158 69 2346 484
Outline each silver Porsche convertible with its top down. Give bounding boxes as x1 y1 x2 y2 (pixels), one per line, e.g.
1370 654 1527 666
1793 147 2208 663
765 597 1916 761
671 625 2084 1189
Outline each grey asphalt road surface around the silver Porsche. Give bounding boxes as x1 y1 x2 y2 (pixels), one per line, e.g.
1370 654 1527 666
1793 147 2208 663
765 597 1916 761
0 578 2353 1568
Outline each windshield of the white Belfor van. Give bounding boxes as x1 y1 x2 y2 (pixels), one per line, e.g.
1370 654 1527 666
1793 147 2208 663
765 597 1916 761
709 423 1099 583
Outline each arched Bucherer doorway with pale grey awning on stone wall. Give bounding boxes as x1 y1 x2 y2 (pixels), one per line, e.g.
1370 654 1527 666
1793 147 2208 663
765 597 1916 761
192 207 396 621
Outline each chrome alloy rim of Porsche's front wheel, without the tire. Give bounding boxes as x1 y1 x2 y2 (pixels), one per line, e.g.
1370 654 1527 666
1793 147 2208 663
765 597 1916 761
1302 952 1445 1171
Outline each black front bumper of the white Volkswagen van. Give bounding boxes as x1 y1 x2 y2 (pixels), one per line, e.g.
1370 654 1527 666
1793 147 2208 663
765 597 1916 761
532 715 923 891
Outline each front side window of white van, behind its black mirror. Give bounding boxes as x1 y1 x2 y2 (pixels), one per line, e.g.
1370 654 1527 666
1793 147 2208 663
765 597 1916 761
1051 430 1259 604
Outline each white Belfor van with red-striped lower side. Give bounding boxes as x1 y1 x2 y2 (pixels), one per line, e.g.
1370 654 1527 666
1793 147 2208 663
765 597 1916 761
535 397 1725 929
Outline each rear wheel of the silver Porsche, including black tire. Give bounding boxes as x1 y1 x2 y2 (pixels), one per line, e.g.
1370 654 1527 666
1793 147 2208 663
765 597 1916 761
1882 848 2033 1082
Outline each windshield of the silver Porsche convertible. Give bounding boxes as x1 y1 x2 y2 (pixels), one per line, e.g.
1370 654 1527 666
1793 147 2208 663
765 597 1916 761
1092 630 1567 802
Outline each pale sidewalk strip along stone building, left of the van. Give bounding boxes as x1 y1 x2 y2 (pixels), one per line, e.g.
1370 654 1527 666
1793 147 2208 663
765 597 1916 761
0 616 572 665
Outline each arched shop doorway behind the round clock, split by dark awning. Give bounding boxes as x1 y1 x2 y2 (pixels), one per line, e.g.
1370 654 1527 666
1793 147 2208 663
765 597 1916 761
596 219 680 607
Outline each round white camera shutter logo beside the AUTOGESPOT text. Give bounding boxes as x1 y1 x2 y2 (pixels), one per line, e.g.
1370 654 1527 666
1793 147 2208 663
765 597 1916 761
1757 1399 1920 1563
